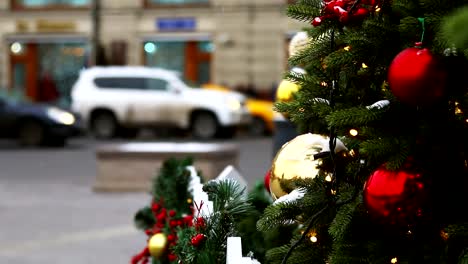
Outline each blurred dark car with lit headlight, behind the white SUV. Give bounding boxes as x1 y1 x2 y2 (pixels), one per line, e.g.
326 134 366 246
0 97 83 146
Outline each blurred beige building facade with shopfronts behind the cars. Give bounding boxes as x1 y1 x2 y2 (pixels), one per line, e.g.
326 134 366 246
0 0 307 104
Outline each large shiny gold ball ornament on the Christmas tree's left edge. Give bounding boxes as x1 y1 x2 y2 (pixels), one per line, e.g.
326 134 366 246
270 133 347 199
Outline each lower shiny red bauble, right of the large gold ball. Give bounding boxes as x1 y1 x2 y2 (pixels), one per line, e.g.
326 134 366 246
363 166 428 227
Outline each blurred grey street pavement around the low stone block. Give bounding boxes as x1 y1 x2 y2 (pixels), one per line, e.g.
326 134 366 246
0 137 272 264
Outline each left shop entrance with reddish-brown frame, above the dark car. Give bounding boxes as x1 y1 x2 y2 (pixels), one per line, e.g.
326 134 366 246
10 42 87 107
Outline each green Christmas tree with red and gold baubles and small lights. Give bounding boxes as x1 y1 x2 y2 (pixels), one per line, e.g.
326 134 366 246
257 0 468 264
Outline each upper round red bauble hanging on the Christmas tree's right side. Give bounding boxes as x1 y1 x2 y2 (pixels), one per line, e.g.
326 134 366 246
388 47 447 106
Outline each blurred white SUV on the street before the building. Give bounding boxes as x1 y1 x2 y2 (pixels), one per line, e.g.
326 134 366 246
71 66 250 139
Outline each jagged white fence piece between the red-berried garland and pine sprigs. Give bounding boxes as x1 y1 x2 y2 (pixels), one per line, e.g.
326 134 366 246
187 166 213 217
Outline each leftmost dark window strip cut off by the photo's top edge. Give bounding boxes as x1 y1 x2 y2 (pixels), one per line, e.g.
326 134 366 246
12 0 91 9
